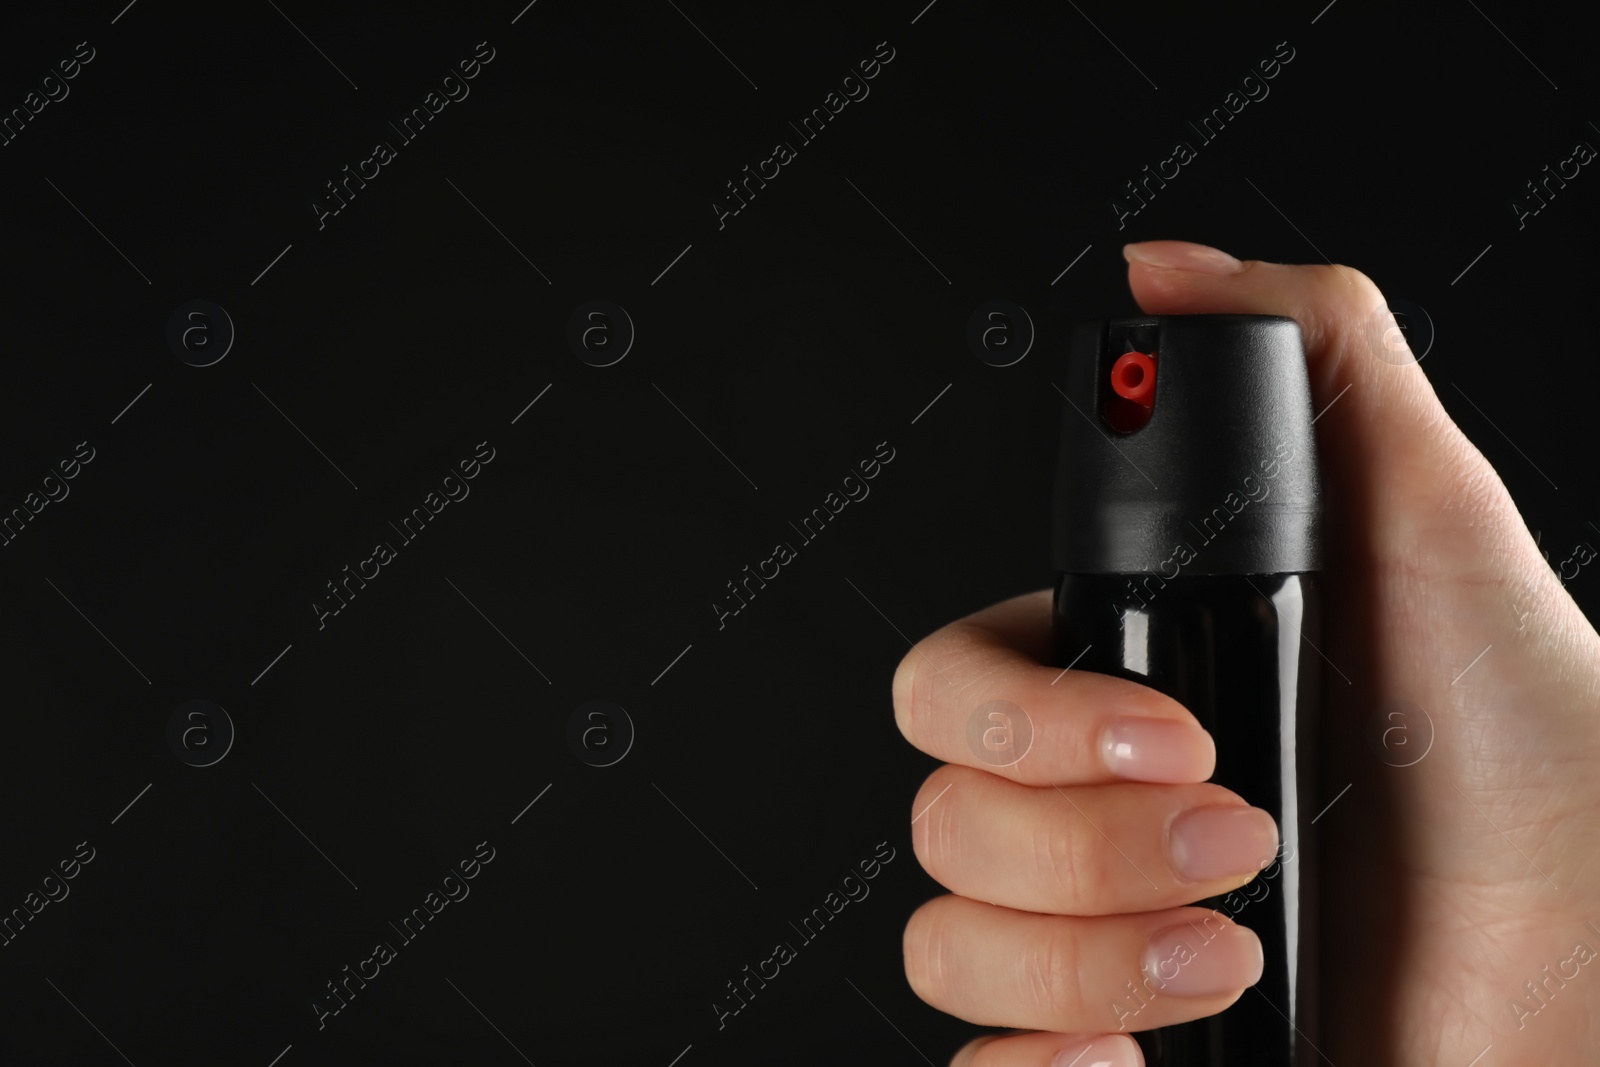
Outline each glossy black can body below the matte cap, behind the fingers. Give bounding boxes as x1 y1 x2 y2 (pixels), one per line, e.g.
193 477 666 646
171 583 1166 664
1054 574 1322 1067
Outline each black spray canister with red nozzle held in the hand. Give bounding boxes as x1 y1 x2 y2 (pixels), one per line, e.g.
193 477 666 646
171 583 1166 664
1054 315 1322 1067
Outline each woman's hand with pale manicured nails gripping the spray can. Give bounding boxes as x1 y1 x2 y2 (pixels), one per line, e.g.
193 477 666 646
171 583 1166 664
894 242 1600 1067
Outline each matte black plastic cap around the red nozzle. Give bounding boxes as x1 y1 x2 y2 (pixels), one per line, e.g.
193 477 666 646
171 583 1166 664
1054 315 1322 579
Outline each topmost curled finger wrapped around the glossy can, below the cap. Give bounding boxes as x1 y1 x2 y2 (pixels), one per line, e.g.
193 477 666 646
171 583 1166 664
893 589 1216 785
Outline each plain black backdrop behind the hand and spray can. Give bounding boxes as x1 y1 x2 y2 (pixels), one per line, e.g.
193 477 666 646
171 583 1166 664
0 0 1600 1067
